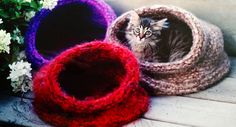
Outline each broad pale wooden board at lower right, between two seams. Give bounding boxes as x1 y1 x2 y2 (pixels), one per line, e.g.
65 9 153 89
144 96 236 127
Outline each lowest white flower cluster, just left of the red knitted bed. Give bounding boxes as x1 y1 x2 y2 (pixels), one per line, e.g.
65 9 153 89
7 60 32 92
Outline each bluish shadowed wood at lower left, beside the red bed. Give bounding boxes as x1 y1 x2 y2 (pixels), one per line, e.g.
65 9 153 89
0 95 49 127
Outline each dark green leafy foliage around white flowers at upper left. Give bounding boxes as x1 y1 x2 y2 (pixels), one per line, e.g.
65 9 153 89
0 0 42 91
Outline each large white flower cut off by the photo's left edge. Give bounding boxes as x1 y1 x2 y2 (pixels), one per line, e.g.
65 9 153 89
0 30 11 54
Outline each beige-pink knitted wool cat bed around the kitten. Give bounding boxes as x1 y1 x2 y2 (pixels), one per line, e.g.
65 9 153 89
108 5 230 95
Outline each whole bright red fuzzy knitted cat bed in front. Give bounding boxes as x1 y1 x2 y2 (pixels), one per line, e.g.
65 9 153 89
33 41 149 127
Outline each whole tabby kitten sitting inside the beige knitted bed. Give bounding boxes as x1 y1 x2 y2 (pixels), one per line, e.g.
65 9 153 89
125 11 191 62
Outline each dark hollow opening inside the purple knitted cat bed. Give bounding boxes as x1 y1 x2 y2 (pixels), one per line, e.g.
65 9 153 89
36 2 107 59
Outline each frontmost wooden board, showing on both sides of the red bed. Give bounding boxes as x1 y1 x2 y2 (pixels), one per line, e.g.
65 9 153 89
0 95 186 127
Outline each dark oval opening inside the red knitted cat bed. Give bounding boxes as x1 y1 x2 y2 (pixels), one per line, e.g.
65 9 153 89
58 51 126 100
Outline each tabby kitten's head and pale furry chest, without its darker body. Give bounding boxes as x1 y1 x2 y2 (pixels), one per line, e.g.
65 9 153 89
124 11 172 61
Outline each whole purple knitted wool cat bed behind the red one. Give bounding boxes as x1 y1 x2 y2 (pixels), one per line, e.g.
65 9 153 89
25 0 116 68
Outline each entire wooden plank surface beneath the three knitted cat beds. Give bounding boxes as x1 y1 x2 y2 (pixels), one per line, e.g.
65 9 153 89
0 57 236 127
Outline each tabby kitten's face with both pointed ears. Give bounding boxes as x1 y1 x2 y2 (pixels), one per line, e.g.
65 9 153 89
126 11 168 44
